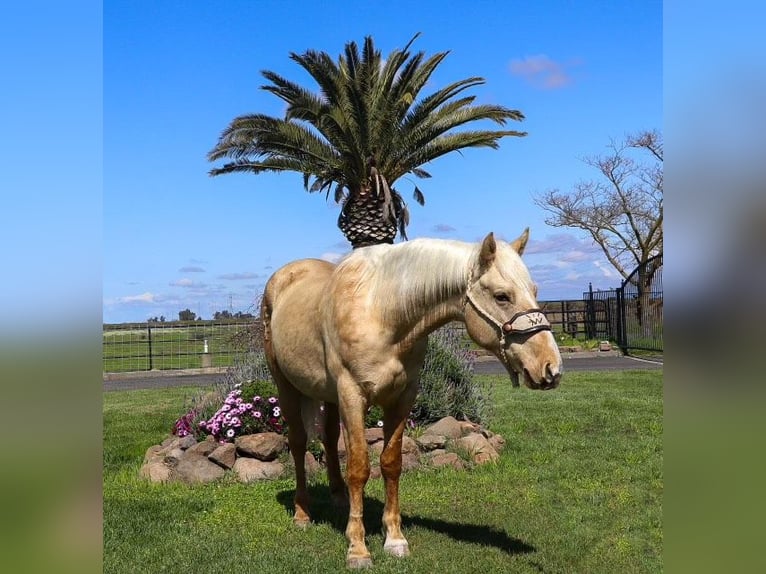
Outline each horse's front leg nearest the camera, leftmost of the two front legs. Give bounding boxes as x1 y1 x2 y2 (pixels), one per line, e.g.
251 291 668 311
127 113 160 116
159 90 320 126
338 385 372 568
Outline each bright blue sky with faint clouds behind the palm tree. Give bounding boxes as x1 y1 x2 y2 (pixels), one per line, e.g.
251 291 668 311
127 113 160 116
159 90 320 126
103 1 663 323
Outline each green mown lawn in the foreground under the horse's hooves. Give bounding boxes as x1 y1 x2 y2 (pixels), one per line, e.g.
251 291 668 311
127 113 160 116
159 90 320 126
103 371 663 574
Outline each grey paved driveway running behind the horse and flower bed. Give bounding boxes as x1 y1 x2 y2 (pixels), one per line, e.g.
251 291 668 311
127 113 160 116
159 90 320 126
104 353 662 391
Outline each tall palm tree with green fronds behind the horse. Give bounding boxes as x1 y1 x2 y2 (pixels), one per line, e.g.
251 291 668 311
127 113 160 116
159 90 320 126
208 34 526 248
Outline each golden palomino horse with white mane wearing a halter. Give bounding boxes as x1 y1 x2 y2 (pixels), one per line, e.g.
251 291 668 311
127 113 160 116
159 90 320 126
261 229 562 568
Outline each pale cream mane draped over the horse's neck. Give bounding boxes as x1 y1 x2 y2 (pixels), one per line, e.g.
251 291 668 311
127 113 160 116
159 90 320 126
337 238 479 328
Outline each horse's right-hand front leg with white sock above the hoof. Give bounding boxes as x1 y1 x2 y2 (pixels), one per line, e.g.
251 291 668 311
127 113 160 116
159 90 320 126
380 393 414 556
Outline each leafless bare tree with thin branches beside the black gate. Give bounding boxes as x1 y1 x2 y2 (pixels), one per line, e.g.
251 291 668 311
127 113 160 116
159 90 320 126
535 130 663 288
